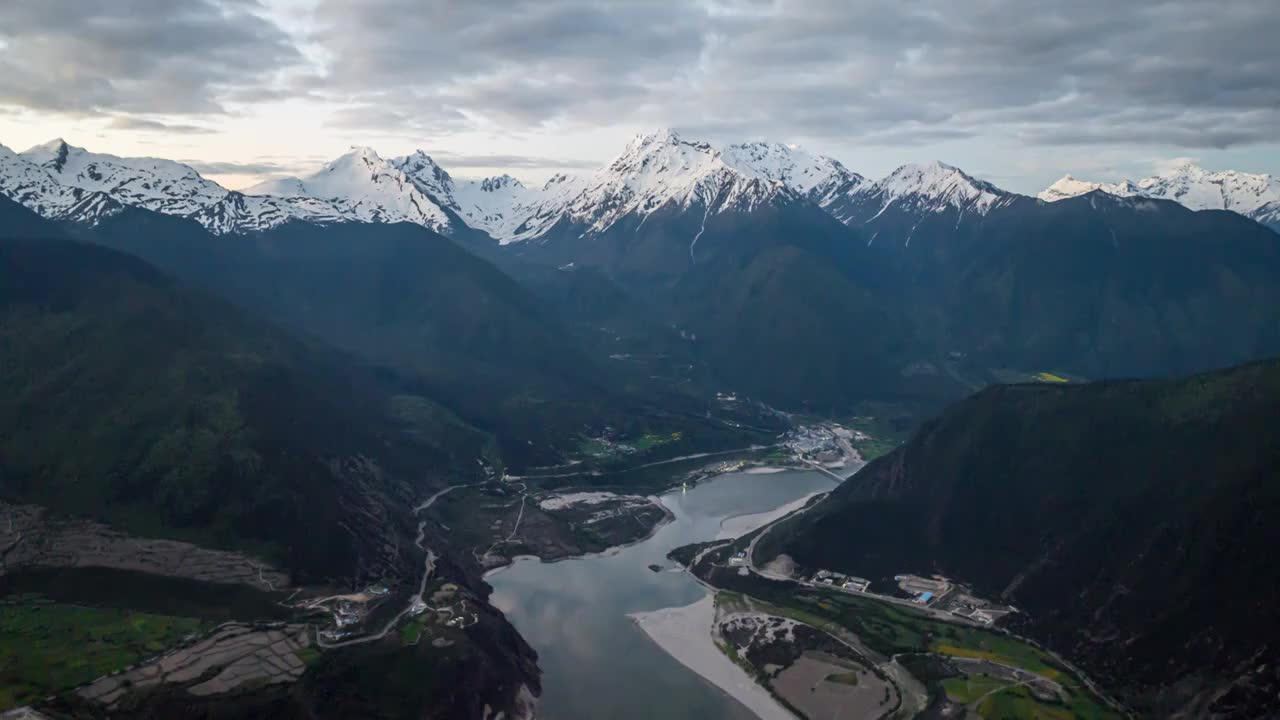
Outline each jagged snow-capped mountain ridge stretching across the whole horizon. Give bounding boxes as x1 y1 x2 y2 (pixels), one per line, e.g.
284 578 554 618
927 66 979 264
0 129 1280 254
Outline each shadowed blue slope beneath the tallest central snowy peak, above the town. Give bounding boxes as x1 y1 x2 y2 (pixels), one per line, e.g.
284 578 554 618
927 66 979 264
513 190 960 413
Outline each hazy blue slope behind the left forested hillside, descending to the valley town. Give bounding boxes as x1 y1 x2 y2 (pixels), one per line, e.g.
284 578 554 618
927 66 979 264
72 210 732 466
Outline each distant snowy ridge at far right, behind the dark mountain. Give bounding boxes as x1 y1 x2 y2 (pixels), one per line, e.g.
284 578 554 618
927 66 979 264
1038 163 1280 223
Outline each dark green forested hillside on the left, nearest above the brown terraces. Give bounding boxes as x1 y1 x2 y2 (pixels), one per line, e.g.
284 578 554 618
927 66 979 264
0 238 486 580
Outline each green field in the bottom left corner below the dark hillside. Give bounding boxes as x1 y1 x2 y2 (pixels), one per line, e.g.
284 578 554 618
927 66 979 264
0 601 206 710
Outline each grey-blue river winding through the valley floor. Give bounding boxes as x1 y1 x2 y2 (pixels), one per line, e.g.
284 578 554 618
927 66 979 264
486 470 835 720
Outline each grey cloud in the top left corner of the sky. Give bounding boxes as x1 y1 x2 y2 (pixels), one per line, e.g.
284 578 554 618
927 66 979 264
0 0 301 114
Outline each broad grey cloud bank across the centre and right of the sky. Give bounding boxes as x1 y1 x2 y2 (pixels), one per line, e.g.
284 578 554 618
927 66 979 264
310 0 1280 147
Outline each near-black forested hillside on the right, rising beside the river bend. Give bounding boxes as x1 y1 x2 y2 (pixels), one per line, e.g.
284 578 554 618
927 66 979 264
768 361 1280 716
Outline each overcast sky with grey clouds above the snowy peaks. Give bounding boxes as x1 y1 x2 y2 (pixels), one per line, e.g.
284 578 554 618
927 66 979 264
0 0 1280 192
